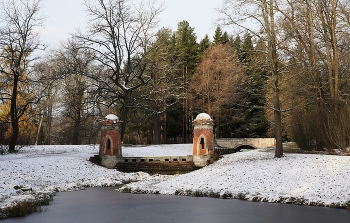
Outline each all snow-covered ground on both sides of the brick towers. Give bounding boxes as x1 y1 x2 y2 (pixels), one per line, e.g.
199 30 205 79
0 144 350 215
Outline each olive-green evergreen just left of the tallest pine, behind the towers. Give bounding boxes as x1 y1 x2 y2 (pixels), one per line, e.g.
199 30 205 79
134 28 182 144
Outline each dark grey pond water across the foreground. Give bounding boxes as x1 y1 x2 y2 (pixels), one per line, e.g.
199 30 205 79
4 188 350 223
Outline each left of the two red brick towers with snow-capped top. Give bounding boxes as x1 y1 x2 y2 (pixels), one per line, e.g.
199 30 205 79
99 114 122 168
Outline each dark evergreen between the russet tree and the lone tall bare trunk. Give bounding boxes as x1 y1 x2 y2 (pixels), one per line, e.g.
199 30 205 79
226 34 269 137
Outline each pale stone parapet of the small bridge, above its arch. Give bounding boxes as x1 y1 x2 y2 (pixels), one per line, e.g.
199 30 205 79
216 138 276 149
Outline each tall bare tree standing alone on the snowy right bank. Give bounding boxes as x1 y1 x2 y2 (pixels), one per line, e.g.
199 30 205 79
218 0 283 158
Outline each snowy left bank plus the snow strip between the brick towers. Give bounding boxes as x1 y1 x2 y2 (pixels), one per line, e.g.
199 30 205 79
0 144 192 218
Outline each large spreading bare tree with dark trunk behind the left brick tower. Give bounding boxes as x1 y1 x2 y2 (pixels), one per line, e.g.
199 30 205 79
75 0 162 139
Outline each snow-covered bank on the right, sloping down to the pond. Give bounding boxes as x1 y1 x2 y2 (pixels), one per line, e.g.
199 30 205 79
120 149 350 206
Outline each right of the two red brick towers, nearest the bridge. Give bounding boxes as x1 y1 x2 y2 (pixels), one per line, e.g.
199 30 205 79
192 113 214 167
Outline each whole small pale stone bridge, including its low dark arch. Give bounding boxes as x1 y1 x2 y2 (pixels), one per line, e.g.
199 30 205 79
214 138 276 155
